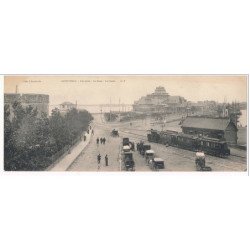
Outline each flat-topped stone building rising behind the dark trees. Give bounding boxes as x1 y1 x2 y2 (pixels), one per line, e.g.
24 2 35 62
4 93 49 118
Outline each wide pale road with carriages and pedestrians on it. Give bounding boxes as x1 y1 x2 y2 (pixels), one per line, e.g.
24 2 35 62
69 115 247 171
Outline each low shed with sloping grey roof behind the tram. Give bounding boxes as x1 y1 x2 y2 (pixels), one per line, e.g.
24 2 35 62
182 116 238 144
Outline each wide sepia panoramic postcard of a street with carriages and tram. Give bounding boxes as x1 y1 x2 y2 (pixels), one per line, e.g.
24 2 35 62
4 75 248 172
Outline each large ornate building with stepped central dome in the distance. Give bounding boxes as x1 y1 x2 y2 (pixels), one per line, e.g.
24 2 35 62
133 86 187 113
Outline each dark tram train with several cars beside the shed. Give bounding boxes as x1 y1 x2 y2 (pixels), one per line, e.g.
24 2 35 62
147 130 230 157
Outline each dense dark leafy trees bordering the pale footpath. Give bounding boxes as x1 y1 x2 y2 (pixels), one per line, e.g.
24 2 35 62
4 102 93 171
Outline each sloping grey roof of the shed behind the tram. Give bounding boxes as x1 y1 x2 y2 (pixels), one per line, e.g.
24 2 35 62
182 116 233 131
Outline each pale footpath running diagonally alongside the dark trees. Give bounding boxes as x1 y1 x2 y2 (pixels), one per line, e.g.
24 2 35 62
47 129 92 171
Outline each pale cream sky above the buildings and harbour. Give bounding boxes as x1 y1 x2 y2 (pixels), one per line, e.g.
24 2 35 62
4 75 247 105
